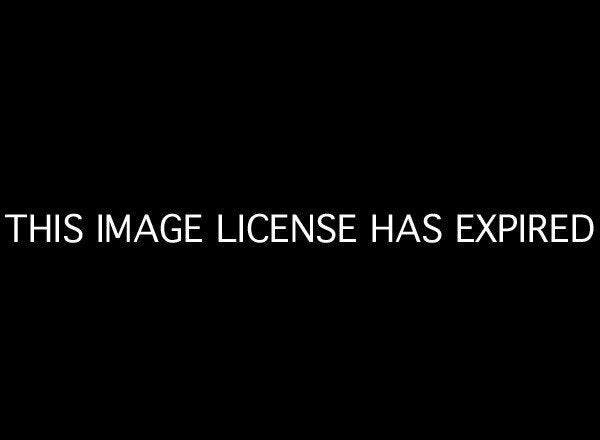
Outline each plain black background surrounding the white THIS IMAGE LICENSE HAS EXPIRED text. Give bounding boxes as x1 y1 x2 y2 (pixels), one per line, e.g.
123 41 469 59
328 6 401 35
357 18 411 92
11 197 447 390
1 5 598 433
